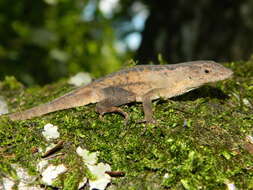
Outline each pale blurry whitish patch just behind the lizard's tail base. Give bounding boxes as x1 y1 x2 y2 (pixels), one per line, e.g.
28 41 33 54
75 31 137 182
68 72 92 87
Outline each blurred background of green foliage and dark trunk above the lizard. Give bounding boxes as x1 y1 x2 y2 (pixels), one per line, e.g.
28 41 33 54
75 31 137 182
0 0 253 86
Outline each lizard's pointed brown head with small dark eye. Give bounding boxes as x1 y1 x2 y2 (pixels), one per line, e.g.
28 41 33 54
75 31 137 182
187 61 233 85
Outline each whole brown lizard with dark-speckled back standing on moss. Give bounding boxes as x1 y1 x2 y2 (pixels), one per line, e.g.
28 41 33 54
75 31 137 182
9 61 233 122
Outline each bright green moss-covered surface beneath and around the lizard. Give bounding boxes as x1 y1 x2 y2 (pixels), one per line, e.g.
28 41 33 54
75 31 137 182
0 61 253 190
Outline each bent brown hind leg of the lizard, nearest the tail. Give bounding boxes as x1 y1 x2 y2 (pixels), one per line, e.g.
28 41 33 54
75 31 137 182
96 87 136 124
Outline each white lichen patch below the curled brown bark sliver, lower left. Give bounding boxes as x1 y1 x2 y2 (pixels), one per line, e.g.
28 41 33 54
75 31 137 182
42 164 67 185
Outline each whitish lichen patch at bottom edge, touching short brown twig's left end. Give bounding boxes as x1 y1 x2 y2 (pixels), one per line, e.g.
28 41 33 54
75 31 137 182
87 163 111 190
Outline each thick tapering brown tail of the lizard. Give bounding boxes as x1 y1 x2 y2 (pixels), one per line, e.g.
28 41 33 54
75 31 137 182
8 89 96 120
